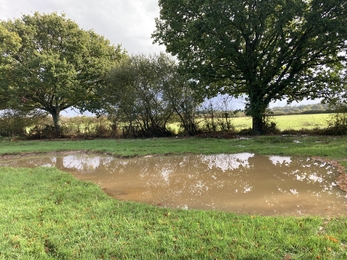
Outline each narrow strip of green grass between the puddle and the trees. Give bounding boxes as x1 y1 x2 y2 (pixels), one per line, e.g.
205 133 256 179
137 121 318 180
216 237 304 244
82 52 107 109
0 136 347 166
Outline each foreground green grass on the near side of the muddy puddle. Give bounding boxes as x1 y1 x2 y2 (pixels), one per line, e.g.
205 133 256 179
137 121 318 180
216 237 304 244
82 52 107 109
0 168 347 259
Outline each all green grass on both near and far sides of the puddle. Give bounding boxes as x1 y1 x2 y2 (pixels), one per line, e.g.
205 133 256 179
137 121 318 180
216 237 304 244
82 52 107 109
0 136 347 259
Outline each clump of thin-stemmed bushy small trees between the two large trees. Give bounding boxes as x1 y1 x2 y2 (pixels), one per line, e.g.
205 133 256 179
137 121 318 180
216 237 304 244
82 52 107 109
104 53 200 136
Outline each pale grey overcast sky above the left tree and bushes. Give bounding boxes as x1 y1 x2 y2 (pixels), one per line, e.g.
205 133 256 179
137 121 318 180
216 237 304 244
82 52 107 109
0 0 165 54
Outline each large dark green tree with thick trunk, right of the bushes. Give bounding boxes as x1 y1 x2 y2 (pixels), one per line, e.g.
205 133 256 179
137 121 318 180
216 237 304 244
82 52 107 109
152 0 347 133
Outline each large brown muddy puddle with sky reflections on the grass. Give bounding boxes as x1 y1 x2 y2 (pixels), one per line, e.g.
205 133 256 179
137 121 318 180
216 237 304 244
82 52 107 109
0 153 347 216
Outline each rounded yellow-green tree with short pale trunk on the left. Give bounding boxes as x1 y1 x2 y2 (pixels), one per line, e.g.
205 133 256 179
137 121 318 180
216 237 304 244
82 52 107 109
0 12 124 135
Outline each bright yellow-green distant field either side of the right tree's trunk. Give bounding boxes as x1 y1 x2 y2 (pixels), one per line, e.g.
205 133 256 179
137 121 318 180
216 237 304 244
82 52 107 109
232 114 332 131
